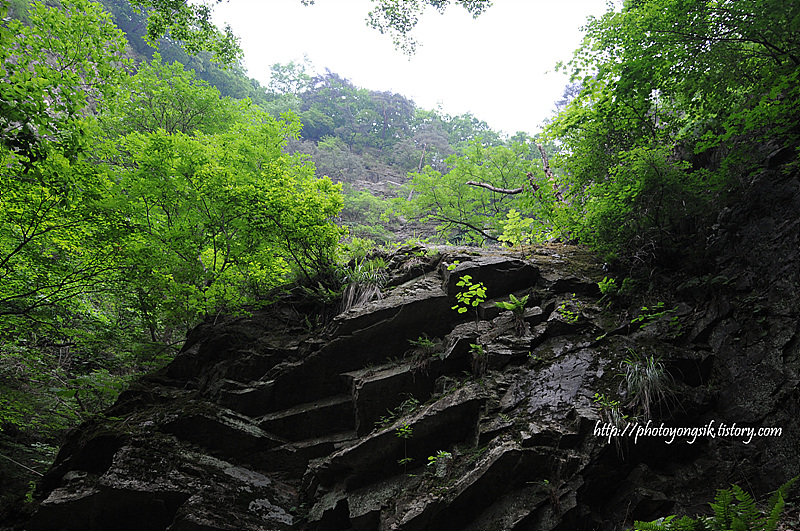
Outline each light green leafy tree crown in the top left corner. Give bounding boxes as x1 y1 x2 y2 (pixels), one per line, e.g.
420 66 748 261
0 0 124 160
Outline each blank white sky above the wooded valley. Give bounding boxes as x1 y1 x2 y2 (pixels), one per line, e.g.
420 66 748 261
209 0 606 134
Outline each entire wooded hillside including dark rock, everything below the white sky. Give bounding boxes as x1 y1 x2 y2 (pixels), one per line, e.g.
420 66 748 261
0 0 800 531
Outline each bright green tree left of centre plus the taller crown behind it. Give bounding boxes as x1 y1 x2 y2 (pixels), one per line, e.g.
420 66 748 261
94 55 342 337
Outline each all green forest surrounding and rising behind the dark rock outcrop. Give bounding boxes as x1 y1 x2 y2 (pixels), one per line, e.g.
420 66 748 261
0 0 800 528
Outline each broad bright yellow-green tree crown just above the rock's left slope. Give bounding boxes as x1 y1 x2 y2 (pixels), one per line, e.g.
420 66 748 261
111 116 341 325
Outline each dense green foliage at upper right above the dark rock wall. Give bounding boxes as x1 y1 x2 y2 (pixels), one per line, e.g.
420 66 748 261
548 0 800 264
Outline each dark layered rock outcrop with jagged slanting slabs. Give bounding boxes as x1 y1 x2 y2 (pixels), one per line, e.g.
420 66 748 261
27 234 800 531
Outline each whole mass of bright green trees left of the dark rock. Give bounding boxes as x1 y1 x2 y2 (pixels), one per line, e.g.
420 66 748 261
0 0 343 492
